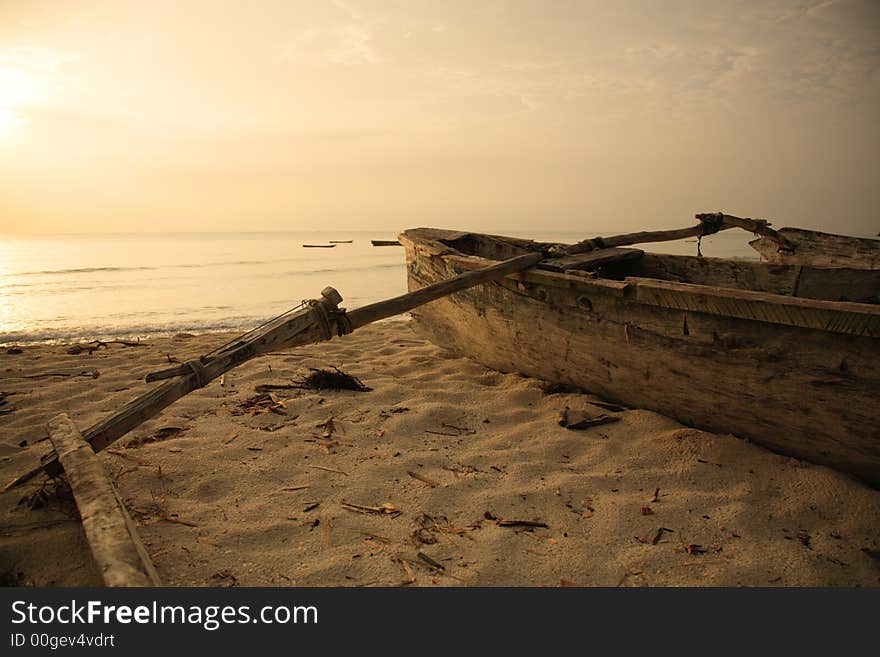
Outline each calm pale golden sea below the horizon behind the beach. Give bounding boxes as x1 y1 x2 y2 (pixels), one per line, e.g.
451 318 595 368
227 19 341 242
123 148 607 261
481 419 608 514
0 230 754 344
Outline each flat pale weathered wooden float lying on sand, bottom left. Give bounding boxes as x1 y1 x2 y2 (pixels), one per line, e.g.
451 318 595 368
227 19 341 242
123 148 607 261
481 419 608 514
48 414 162 586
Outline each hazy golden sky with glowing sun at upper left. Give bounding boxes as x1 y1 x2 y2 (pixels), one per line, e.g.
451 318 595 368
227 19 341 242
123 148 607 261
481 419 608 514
0 0 880 234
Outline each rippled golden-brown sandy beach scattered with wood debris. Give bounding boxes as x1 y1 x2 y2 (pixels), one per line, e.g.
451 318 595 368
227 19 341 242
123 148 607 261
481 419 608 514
0 322 880 586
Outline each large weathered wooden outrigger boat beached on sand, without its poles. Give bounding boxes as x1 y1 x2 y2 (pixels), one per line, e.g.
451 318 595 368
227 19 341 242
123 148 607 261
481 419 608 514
400 215 880 485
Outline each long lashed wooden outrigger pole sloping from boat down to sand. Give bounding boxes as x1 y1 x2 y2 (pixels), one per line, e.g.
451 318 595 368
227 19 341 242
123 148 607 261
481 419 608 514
4 253 543 490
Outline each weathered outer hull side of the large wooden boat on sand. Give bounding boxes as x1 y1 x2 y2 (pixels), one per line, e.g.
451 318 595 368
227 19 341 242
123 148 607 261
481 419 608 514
401 231 880 485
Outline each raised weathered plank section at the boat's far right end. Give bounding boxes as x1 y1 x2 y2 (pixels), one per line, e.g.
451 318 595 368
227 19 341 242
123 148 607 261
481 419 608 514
749 228 880 269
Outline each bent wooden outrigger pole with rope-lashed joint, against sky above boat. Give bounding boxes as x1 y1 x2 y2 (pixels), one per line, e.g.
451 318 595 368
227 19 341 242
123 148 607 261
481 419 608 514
554 212 794 255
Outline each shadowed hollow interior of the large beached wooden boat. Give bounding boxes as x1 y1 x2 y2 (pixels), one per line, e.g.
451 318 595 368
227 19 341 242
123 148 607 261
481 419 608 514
422 229 880 304
